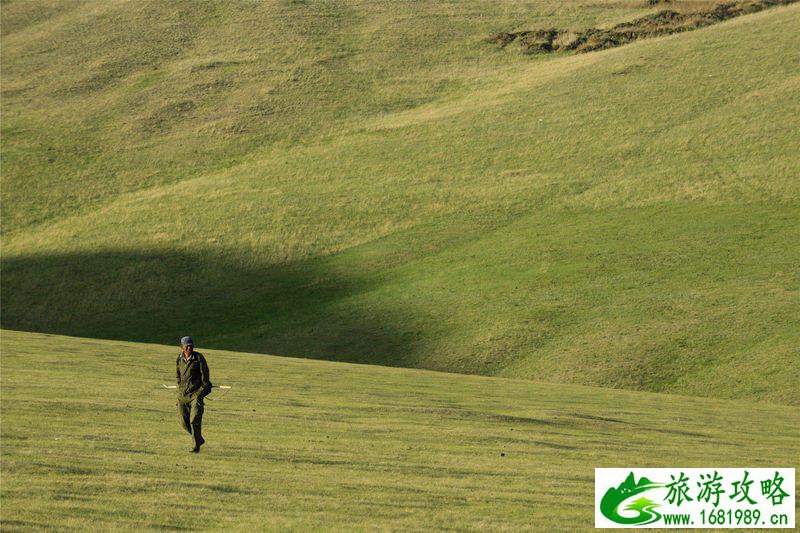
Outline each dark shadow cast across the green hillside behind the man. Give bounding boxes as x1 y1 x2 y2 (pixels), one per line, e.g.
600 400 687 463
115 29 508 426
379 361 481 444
1 252 418 365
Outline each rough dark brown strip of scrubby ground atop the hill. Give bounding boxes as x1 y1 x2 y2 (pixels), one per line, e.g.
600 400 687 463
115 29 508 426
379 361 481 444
488 0 800 54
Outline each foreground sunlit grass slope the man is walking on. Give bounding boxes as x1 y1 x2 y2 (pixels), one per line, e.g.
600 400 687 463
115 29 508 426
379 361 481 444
0 331 800 531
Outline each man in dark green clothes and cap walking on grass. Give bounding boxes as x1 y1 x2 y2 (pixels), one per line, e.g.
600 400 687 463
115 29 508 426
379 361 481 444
175 337 211 453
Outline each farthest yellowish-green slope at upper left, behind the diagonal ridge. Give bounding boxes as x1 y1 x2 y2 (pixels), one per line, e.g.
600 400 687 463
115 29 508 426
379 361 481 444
0 0 668 231
